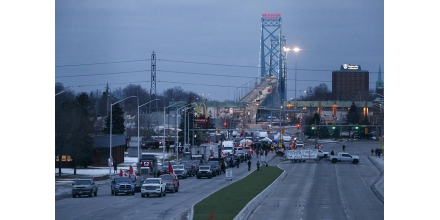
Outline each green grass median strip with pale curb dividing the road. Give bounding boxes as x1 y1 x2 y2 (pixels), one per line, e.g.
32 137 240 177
193 166 283 220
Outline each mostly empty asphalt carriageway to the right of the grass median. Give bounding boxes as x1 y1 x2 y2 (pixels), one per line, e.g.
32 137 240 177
249 141 384 220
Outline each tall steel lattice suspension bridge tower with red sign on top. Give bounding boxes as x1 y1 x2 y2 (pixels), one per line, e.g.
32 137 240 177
260 13 287 106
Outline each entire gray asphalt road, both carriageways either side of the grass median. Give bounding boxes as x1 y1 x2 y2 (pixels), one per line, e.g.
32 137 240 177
55 141 384 219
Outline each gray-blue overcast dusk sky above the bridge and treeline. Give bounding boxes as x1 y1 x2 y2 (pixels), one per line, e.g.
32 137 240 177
55 0 385 101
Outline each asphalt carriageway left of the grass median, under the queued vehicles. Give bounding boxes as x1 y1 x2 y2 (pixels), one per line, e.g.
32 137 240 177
55 154 257 220
